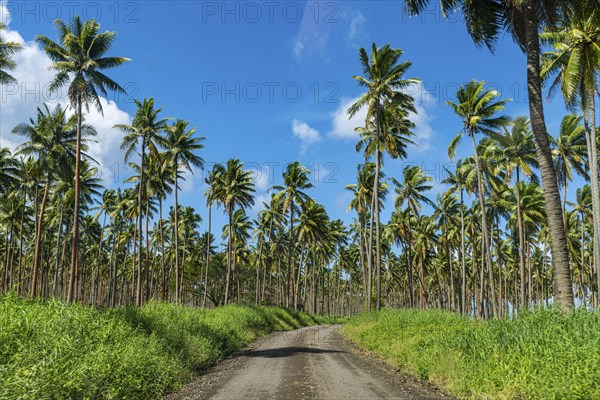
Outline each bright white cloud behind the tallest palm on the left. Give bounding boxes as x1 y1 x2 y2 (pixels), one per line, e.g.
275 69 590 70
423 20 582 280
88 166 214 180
0 2 132 185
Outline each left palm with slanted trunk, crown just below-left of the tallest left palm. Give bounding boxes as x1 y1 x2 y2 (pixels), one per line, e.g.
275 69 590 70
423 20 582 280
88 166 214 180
12 104 96 297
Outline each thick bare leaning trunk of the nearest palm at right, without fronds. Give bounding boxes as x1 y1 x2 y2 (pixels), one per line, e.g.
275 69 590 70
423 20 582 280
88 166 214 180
525 2 573 310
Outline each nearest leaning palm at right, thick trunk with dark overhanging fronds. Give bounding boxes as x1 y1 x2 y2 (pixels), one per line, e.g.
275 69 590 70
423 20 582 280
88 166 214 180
405 0 579 309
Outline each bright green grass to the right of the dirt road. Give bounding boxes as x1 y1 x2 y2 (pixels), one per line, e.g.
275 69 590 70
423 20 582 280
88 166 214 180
342 309 600 399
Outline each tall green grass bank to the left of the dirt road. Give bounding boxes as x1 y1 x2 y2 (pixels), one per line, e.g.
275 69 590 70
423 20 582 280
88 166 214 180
0 294 327 399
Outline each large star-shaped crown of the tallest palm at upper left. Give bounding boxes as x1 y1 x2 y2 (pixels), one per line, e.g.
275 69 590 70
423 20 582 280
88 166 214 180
36 16 130 112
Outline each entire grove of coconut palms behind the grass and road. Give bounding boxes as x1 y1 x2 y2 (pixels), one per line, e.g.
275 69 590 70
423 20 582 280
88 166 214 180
0 0 600 318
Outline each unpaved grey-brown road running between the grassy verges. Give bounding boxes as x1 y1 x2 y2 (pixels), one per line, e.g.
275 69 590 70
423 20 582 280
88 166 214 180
166 325 448 400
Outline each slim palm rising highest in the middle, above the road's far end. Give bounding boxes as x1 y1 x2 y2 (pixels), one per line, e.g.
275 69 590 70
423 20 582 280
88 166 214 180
273 161 313 307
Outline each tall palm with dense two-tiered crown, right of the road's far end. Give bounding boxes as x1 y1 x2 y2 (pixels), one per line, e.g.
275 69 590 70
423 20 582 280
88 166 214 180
348 43 418 310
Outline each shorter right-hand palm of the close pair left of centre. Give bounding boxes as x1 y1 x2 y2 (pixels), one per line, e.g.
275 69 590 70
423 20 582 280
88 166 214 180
162 119 204 301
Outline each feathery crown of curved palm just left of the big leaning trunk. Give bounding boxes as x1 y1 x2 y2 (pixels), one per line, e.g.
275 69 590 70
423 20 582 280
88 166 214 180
446 80 510 158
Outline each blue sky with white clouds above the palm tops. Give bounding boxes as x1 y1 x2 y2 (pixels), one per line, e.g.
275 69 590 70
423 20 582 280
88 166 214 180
0 1 576 234
